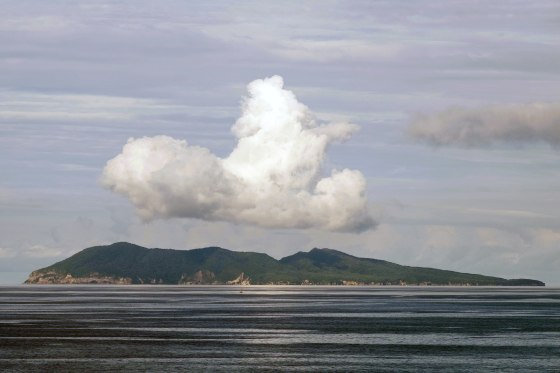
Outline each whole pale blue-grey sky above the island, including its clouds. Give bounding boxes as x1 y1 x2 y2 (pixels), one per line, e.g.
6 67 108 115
0 0 560 285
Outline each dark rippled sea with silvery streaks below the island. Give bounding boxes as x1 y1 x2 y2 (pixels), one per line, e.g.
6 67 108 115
0 285 560 372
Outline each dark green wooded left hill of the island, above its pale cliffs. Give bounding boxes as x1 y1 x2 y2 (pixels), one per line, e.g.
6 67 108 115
26 242 280 284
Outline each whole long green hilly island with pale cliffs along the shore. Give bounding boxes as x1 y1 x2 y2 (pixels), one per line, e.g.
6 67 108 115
25 242 545 286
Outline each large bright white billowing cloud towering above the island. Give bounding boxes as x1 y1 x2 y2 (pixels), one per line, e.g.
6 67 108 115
102 76 375 232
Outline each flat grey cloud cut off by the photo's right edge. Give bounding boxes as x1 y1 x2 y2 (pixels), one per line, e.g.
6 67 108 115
408 103 560 148
